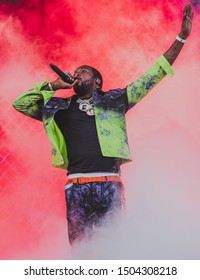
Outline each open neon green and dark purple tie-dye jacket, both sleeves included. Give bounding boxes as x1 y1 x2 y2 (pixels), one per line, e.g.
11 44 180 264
13 56 174 169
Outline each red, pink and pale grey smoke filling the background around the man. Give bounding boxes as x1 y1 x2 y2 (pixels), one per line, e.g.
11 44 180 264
0 0 200 259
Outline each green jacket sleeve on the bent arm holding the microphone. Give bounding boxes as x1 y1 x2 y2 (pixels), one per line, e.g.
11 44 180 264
12 82 55 121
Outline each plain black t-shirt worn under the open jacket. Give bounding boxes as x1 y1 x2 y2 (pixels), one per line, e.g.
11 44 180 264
55 97 118 175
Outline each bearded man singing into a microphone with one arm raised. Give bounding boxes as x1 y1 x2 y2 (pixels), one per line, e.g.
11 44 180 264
13 5 193 244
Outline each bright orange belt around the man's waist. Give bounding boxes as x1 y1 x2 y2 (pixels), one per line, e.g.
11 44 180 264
66 176 121 185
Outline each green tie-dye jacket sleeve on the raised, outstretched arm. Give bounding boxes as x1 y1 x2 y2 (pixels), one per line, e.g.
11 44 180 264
126 55 174 109
